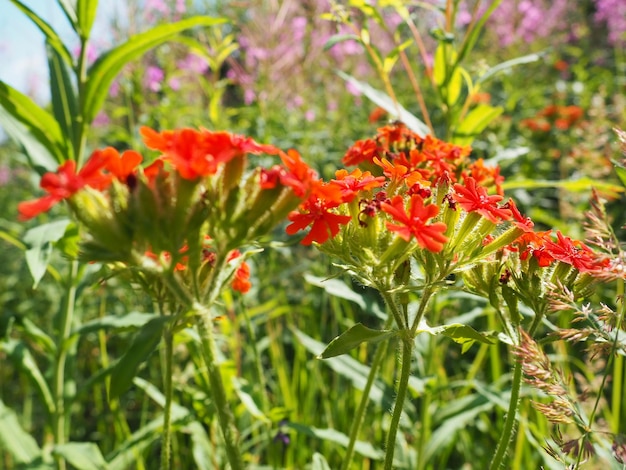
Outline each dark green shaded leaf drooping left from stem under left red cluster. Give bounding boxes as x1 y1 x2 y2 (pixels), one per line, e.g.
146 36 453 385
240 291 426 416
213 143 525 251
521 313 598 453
109 316 172 398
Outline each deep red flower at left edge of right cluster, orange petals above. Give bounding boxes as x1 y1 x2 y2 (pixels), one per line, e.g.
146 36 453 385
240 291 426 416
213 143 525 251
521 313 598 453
285 181 351 245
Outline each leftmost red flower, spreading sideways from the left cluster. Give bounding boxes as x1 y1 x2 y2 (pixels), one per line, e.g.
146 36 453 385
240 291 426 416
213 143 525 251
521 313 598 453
17 152 111 220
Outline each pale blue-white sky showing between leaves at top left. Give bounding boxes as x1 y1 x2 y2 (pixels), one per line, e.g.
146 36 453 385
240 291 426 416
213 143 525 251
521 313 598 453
0 0 123 104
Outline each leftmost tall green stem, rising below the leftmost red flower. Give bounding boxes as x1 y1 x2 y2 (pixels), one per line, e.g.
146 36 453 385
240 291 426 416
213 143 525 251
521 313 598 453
53 261 78 470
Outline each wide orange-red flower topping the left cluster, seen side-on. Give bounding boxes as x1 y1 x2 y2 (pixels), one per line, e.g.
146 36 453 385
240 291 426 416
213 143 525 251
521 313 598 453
140 127 278 180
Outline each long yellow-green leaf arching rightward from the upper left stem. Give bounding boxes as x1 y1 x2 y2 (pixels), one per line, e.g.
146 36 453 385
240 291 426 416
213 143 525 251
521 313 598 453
83 16 226 124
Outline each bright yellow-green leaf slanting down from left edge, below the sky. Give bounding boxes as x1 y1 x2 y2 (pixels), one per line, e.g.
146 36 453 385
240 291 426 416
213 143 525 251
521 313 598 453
0 81 67 162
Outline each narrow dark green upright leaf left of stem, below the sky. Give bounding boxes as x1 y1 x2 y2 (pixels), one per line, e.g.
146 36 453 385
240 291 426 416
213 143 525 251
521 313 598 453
46 42 77 160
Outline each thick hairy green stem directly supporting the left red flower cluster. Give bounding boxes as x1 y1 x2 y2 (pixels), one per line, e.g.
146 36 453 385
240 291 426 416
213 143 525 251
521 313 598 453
197 310 244 470
